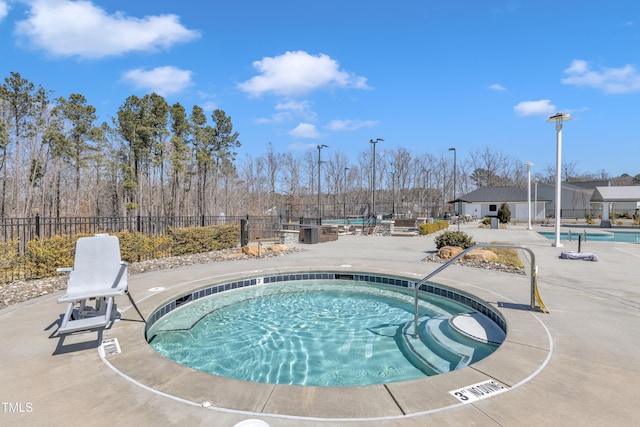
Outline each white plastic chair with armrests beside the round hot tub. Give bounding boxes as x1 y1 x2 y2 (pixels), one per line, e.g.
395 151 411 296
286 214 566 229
58 234 128 333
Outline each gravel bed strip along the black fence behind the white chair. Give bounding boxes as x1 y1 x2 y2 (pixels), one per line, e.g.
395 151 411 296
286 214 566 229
0 248 302 309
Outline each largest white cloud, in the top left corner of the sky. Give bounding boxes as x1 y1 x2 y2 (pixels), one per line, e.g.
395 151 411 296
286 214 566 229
16 0 199 58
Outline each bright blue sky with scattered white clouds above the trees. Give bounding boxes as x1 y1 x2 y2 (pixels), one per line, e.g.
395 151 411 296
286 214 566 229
0 0 640 176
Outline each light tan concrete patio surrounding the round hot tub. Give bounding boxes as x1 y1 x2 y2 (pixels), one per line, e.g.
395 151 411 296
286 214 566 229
0 223 640 427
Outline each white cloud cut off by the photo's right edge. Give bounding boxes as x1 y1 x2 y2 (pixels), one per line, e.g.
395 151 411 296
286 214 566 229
562 59 640 93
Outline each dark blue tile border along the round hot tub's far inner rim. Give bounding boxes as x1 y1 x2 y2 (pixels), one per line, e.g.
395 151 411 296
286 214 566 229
145 272 507 333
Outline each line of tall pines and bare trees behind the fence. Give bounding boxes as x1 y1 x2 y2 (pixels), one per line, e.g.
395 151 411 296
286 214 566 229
0 72 640 218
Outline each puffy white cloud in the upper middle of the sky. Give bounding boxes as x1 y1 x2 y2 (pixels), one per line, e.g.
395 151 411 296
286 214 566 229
238 51 368 96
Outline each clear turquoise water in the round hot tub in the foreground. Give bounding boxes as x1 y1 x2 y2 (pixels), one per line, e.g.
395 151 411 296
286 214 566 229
147 280 497 386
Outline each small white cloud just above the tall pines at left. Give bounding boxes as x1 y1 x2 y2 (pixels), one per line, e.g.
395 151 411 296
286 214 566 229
122 66 192 96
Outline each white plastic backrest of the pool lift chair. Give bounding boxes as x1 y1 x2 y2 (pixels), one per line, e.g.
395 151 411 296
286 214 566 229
68 235 127 292
